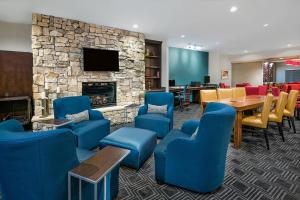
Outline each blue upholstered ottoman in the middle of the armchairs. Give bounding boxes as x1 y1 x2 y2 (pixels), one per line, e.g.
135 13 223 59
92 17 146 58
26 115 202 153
99 127 156 169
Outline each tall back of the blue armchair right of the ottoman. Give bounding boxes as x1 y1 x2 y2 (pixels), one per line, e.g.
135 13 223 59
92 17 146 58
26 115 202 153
191 102 236 184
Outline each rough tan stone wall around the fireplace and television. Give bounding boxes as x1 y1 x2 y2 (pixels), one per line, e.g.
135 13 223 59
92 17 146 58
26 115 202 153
32 14 145 115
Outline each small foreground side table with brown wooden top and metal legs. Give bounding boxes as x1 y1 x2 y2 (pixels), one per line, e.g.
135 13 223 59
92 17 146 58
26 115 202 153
68 146 130 200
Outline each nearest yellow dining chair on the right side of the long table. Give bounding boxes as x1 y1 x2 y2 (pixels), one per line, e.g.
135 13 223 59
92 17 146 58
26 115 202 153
242 94 273 150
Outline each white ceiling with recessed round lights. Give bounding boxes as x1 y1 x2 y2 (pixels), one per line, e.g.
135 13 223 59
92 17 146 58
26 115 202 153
0 0 300 55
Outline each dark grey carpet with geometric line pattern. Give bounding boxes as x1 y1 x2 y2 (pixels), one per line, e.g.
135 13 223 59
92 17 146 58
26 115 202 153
117 105 300 200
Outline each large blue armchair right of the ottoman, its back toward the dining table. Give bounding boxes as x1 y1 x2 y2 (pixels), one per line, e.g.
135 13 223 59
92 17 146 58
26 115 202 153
154 103 236 193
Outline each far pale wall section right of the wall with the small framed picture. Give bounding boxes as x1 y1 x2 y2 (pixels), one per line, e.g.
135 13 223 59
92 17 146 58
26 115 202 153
232 62 263 86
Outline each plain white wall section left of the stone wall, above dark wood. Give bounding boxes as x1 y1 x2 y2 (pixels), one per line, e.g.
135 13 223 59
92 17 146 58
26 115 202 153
0 21 32 52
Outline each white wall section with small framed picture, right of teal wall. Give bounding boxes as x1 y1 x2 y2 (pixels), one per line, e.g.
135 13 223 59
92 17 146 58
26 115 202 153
208 51 232 85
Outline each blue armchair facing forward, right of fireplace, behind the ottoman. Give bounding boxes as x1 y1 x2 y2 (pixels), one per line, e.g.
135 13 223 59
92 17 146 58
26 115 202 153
135 92 174 138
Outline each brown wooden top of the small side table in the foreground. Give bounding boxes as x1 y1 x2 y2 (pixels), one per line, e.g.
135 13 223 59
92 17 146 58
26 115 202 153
69 146 130 184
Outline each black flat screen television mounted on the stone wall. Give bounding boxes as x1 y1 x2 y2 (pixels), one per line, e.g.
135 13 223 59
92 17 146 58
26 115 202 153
83 48 119 71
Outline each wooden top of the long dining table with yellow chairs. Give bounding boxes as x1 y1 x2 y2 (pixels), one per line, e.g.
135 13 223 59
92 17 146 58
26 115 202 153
203 95 278 110
